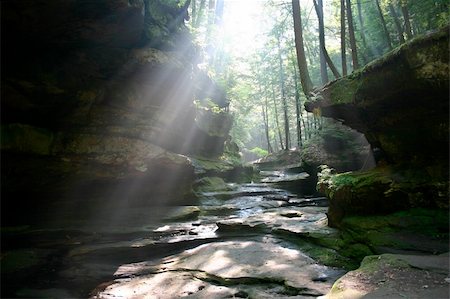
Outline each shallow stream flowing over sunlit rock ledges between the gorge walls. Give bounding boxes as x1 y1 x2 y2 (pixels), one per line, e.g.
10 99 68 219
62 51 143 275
2 172 345 298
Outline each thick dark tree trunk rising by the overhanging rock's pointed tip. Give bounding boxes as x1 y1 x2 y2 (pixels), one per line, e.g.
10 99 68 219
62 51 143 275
292 0 313 98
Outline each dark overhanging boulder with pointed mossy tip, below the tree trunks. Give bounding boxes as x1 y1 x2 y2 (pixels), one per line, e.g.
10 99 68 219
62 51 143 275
305 27 449 166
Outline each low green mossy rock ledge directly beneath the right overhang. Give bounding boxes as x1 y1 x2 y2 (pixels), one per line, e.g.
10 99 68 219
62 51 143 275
317 167 448 227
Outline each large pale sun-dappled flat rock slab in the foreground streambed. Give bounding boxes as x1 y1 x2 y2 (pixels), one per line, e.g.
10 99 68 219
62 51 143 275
95 241 342 298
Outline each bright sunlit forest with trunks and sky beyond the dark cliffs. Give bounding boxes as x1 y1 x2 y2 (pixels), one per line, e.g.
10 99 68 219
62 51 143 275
185 0 449 161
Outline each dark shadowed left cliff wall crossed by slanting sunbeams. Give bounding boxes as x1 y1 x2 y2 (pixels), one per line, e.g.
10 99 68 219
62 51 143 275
1 0 231 225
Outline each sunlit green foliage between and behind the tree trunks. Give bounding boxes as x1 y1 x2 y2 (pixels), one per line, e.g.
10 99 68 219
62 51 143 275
185 0 449 157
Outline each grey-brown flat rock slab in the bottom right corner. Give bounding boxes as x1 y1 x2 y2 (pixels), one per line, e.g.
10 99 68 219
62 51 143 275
321 254 450 299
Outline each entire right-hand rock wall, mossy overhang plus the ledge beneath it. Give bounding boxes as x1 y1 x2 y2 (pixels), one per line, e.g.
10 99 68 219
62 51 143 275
305 28 449 226
